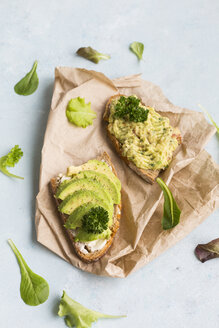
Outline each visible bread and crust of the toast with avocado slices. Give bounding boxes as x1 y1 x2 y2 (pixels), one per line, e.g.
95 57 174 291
50 152 122 263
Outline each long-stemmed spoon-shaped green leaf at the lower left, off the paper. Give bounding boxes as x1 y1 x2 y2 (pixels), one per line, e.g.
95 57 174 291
8 239 49 306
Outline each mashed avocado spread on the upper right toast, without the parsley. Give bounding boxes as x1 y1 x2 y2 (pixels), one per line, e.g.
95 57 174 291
108 96 178 170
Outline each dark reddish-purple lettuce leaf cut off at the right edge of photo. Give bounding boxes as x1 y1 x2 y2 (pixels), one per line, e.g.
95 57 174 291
195 238 219 263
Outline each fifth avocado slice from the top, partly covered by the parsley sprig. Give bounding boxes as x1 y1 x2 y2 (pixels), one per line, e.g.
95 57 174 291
64 201 113 229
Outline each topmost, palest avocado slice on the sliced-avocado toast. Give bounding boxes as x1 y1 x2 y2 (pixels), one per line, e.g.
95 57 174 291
67 159 121 192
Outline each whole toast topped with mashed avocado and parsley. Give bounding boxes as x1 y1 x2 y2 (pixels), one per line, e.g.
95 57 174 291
103 94 181 184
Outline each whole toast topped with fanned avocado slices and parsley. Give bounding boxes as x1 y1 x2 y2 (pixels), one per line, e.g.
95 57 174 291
50 152 122 263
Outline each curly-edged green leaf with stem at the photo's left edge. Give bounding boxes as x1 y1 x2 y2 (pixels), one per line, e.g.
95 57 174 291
0 145 23 179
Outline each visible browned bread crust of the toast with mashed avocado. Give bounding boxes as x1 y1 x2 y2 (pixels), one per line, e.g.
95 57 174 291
103 94 181 184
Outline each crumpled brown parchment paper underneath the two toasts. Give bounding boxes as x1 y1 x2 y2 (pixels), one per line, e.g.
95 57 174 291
35 67 219 277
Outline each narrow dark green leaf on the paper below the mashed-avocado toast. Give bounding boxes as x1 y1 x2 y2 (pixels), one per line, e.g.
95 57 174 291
157 178 181 230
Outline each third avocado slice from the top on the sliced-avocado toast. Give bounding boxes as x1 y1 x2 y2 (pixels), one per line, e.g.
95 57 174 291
56 178 113 205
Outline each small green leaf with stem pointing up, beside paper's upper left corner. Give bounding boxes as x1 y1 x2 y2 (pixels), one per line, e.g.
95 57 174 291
14 61 39 96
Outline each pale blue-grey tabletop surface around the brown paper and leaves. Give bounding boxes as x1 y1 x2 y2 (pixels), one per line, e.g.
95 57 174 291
0 0 219 328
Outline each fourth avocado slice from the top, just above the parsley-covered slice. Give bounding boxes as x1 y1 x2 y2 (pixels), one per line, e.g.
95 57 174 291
59 189 114 219
